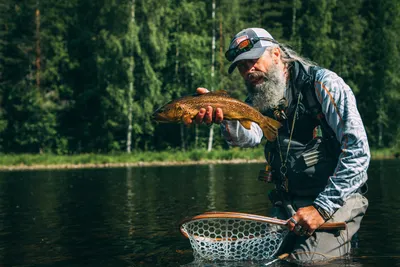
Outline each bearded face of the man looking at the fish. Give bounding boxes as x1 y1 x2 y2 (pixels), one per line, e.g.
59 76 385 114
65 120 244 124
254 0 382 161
237 50 286 112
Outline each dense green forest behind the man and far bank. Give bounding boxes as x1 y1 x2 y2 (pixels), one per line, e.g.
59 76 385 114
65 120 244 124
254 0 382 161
0 0 400 155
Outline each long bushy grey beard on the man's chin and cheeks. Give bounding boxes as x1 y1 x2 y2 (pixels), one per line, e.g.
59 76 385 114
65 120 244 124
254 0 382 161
245 65 286 113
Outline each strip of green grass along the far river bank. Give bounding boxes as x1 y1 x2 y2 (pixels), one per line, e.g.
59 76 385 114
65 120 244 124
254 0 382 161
0 146 396 166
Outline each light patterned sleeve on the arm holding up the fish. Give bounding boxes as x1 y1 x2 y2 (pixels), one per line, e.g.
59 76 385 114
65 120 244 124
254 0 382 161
221 120 263 147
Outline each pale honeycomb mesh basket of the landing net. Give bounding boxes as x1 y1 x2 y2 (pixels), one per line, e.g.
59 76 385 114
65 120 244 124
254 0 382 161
181 213 288 261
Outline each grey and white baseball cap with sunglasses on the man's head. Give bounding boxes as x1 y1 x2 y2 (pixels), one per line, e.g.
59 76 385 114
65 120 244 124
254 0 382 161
225 28 278 74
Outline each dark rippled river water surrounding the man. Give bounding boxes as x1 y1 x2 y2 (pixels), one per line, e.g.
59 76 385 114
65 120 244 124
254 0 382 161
0 160 400 267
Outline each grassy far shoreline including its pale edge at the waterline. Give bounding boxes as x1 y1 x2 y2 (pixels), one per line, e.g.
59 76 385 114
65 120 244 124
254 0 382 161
0 148 399 171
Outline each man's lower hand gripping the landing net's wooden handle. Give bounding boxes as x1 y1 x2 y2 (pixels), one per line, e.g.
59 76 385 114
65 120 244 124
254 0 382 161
288 206 325 236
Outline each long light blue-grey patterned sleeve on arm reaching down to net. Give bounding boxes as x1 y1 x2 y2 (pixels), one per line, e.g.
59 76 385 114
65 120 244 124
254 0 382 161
315 69 370 214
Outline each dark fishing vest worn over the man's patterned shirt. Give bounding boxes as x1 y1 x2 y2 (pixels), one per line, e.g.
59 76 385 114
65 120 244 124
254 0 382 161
265 61 341 197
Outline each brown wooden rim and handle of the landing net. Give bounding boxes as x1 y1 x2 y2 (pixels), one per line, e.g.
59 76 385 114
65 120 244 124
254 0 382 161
179 211 346 238
